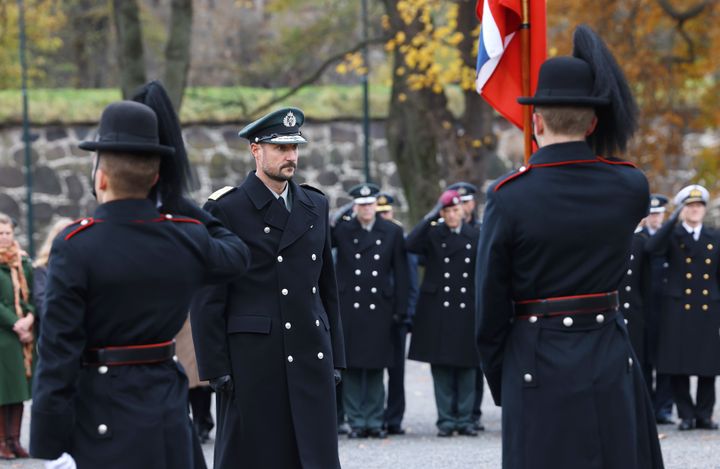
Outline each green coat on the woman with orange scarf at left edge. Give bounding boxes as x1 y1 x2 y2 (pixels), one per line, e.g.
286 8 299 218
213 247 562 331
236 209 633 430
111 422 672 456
0 254 35 405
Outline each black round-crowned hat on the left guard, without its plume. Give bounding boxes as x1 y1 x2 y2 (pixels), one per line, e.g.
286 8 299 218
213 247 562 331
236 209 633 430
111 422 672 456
79 101 175 156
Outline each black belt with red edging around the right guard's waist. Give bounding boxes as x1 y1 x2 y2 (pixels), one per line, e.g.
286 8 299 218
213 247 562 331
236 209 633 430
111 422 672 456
514 291 619 319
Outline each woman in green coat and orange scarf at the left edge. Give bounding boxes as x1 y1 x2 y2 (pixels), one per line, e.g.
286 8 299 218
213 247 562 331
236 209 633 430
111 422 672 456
0 213 35 459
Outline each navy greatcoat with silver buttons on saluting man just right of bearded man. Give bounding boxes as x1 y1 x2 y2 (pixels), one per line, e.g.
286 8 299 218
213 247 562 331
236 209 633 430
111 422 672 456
332 217 410 369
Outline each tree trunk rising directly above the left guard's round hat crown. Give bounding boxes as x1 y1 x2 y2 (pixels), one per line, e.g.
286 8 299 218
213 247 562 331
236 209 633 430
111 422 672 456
113 0 147 99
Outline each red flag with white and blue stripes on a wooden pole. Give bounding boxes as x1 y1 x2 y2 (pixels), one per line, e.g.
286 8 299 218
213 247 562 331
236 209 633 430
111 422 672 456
476 0 547 129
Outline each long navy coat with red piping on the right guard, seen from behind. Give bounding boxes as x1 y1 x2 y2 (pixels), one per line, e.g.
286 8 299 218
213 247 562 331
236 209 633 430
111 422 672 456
477 142 663 469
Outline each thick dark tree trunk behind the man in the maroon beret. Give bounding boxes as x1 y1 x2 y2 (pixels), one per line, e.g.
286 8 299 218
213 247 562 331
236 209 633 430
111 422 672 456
384 0 495 222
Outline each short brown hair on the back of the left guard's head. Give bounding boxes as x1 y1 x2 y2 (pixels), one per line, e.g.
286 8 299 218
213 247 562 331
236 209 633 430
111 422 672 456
98 153 160 197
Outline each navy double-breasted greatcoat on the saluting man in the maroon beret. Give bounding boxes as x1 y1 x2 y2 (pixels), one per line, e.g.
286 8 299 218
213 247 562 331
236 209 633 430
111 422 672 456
405 220 480 368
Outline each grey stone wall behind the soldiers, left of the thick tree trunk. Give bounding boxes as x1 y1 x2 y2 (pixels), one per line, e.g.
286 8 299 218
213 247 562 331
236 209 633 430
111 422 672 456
0 121 406 249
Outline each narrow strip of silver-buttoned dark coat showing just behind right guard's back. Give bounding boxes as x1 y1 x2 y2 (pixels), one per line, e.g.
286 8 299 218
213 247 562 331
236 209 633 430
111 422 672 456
618 231 651 364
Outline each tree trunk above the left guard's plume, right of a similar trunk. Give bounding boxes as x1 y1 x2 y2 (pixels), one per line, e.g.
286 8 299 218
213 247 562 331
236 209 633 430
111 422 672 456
163 0 193 114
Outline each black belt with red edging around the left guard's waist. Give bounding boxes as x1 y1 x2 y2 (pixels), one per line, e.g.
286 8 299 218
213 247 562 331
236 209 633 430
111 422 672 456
83 339 175 366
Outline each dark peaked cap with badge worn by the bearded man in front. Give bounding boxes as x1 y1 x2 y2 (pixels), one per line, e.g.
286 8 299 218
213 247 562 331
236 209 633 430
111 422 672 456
238 107 307 145
